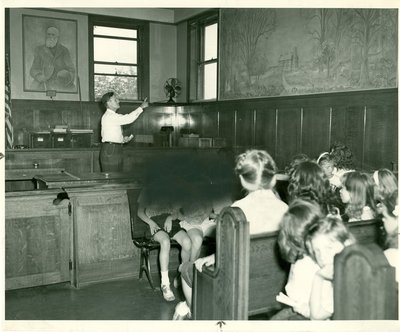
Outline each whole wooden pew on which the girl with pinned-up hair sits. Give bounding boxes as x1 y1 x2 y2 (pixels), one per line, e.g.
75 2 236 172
192 207 381 320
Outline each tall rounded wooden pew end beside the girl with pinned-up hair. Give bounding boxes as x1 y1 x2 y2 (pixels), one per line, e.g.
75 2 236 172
192 207 249 320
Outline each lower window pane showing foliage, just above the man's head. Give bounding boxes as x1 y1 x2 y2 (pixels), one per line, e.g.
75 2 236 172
94 75 138 100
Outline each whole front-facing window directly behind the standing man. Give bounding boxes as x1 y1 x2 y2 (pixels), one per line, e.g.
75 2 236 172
90 18 148 101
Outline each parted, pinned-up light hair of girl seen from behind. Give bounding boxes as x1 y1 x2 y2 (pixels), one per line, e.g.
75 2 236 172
235 150 277 191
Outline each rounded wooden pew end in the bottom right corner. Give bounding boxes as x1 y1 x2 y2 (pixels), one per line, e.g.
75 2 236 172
334 243 398 320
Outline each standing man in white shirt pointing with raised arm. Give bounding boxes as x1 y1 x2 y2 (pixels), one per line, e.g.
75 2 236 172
100 92 149 172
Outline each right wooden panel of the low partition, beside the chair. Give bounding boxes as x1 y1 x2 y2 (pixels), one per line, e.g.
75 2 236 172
72 188 139 287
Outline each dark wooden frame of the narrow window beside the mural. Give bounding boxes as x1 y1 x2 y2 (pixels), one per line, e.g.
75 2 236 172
187 10 220 102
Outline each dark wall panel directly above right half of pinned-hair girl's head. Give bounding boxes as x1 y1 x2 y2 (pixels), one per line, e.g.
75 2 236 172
255 107 276 159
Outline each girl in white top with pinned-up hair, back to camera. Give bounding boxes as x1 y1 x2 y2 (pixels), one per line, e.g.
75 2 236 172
173 150 287 320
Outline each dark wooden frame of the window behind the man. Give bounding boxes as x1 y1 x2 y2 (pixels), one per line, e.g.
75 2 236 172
88 15 150 103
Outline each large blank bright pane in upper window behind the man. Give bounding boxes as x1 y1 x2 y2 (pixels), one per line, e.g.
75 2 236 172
93 37 137 63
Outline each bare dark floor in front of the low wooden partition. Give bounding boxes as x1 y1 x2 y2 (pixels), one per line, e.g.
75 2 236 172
5 273 183 320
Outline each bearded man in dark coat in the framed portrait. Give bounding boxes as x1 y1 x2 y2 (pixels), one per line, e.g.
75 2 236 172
30 26 75 91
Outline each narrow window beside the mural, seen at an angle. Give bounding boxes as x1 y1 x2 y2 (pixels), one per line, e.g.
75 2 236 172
189 12 218 100
